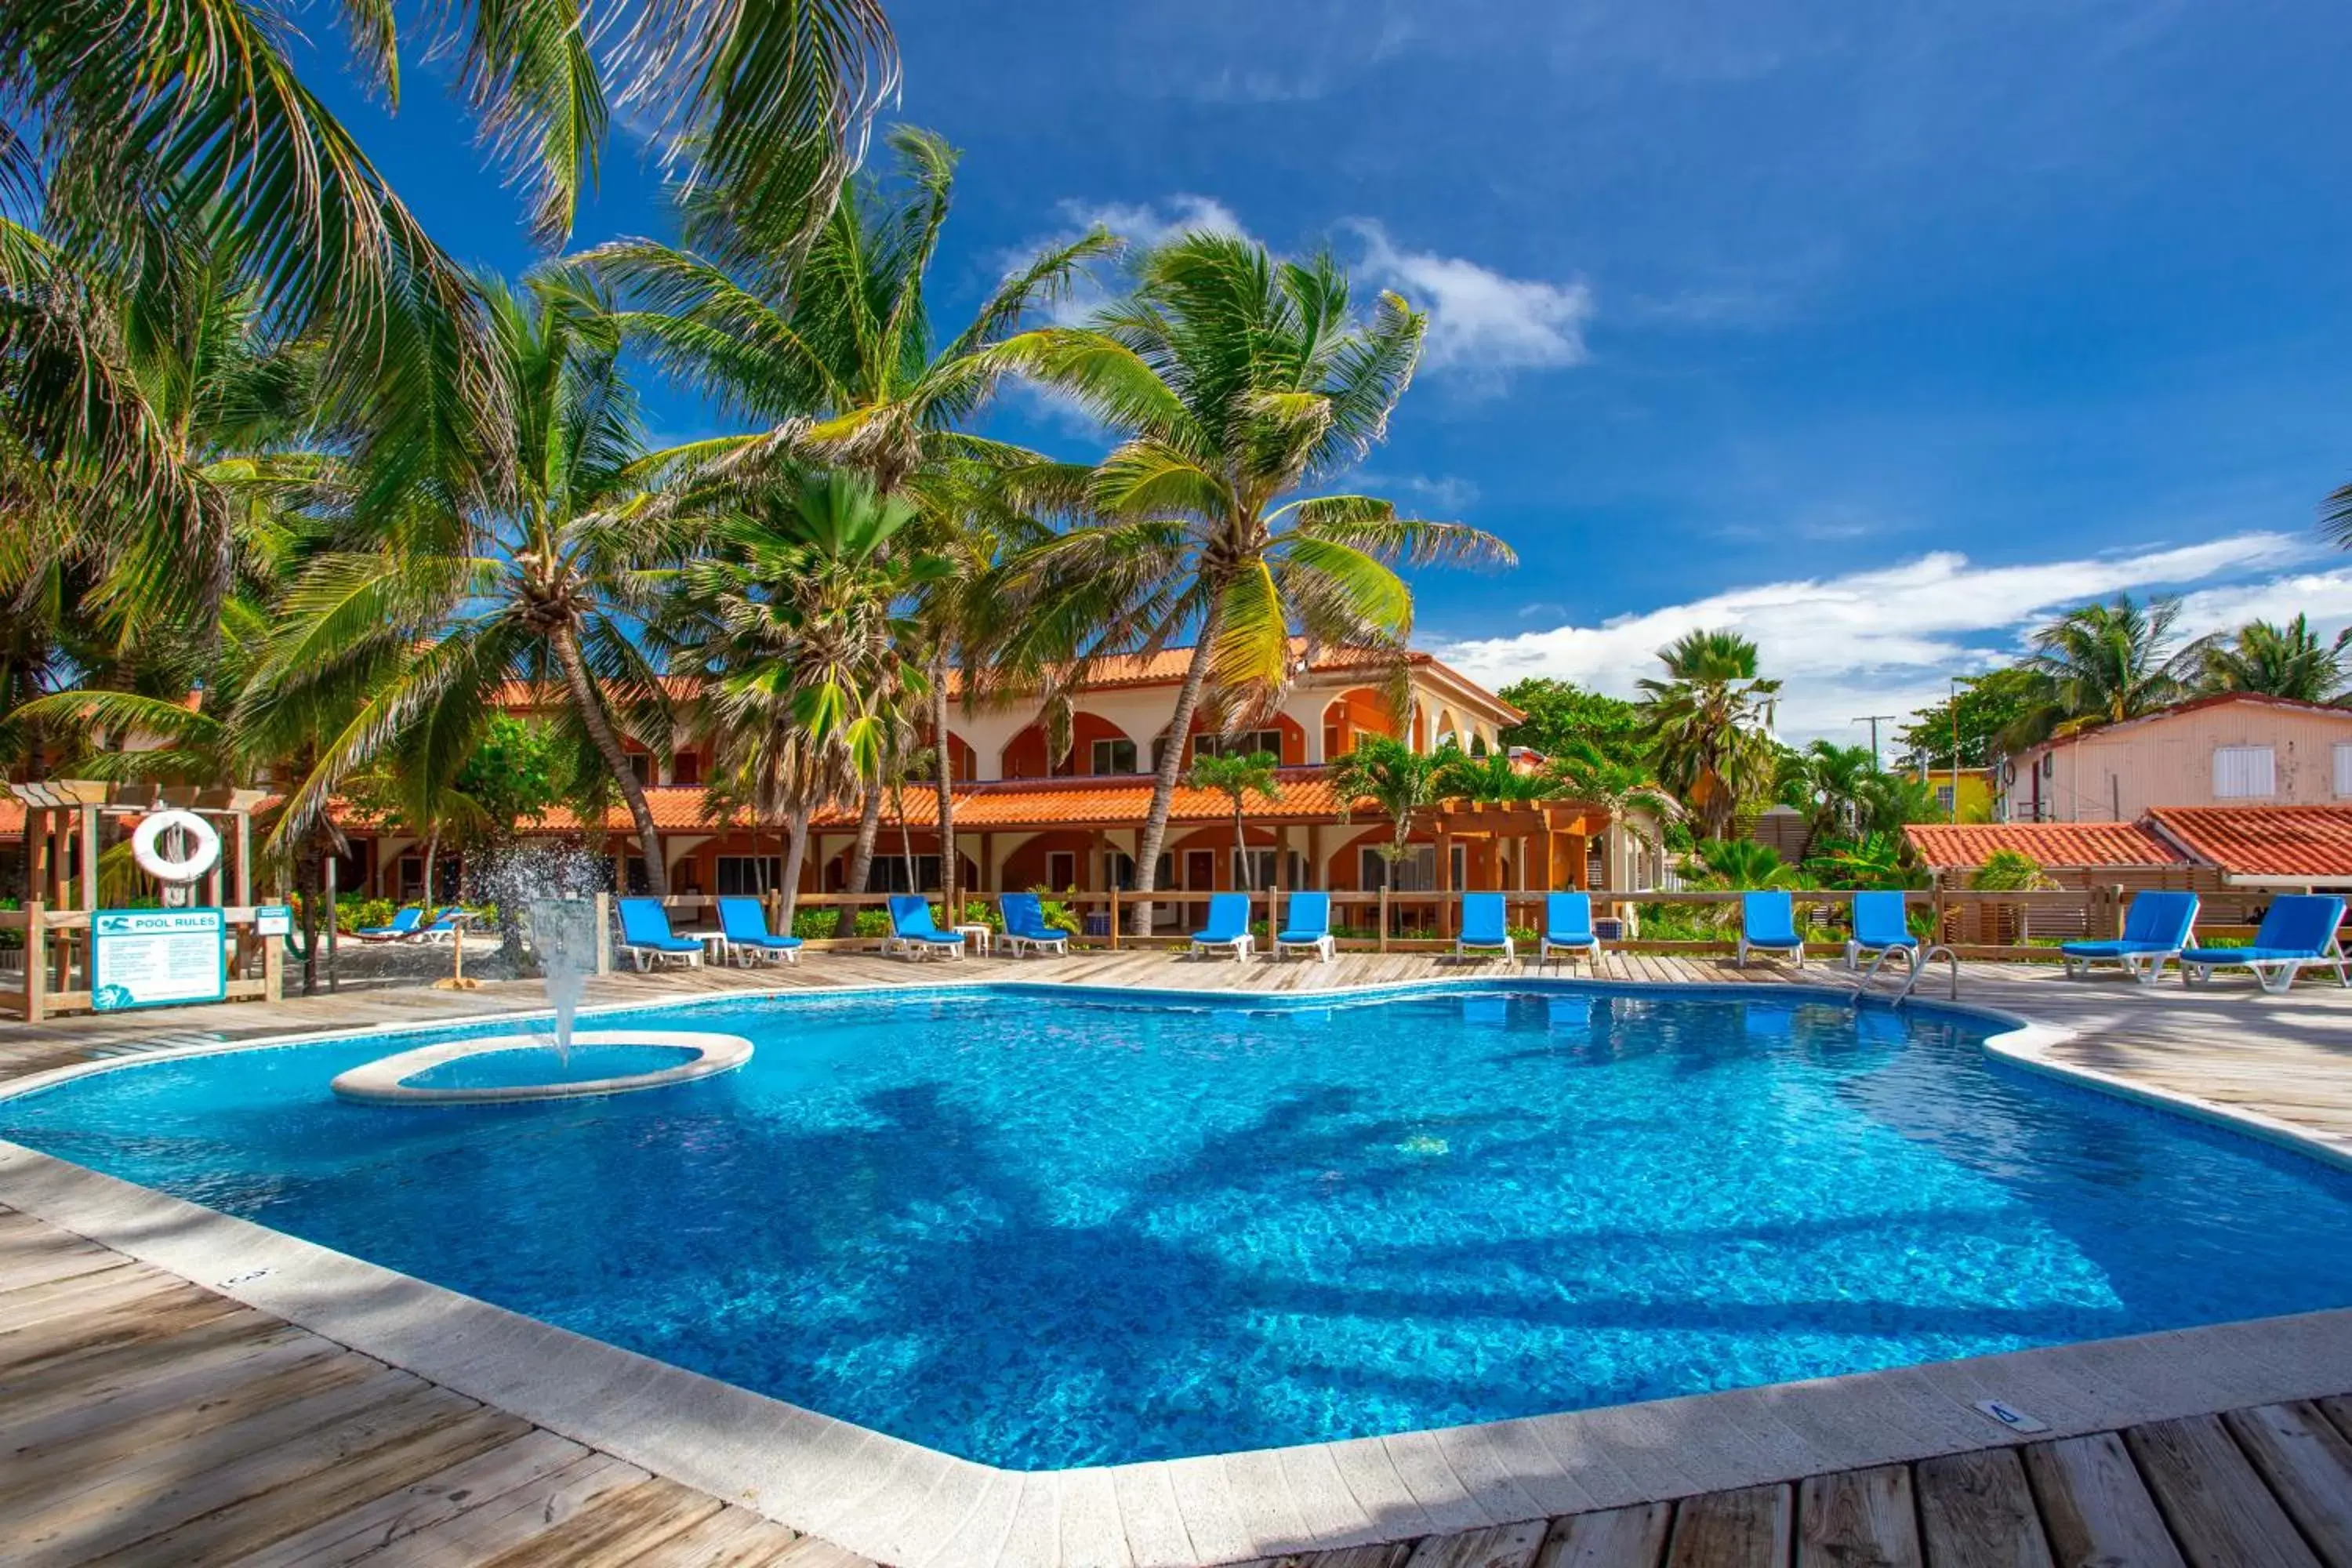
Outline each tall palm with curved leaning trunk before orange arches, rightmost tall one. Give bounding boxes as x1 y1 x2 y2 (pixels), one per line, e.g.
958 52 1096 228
990 235 1512 933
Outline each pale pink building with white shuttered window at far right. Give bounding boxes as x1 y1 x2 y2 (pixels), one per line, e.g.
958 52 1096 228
1999 694 2352 822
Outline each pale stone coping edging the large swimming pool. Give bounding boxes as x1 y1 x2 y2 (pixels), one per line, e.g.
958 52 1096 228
0 973 2352 1568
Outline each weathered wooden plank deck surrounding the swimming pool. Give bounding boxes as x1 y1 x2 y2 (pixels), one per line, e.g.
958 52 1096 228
0 954 2352 1568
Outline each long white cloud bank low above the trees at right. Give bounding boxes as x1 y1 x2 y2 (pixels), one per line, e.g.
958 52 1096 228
1439 534 2352 739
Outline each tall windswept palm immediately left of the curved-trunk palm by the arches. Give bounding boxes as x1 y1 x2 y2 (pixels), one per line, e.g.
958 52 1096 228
586 127 1115 926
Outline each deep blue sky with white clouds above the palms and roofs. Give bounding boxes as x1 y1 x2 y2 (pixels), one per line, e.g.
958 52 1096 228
303 0 2352 739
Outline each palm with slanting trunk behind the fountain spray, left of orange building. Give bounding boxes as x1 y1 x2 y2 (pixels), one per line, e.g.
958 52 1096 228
240 273 689 895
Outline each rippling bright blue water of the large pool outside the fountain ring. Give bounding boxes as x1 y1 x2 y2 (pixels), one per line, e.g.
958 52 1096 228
0 985 2352 1467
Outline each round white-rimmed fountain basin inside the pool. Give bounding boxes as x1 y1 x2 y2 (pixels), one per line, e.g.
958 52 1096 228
329 1029 750 1105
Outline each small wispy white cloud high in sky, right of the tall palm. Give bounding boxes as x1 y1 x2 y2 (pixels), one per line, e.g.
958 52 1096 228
1348 219 1592 374
